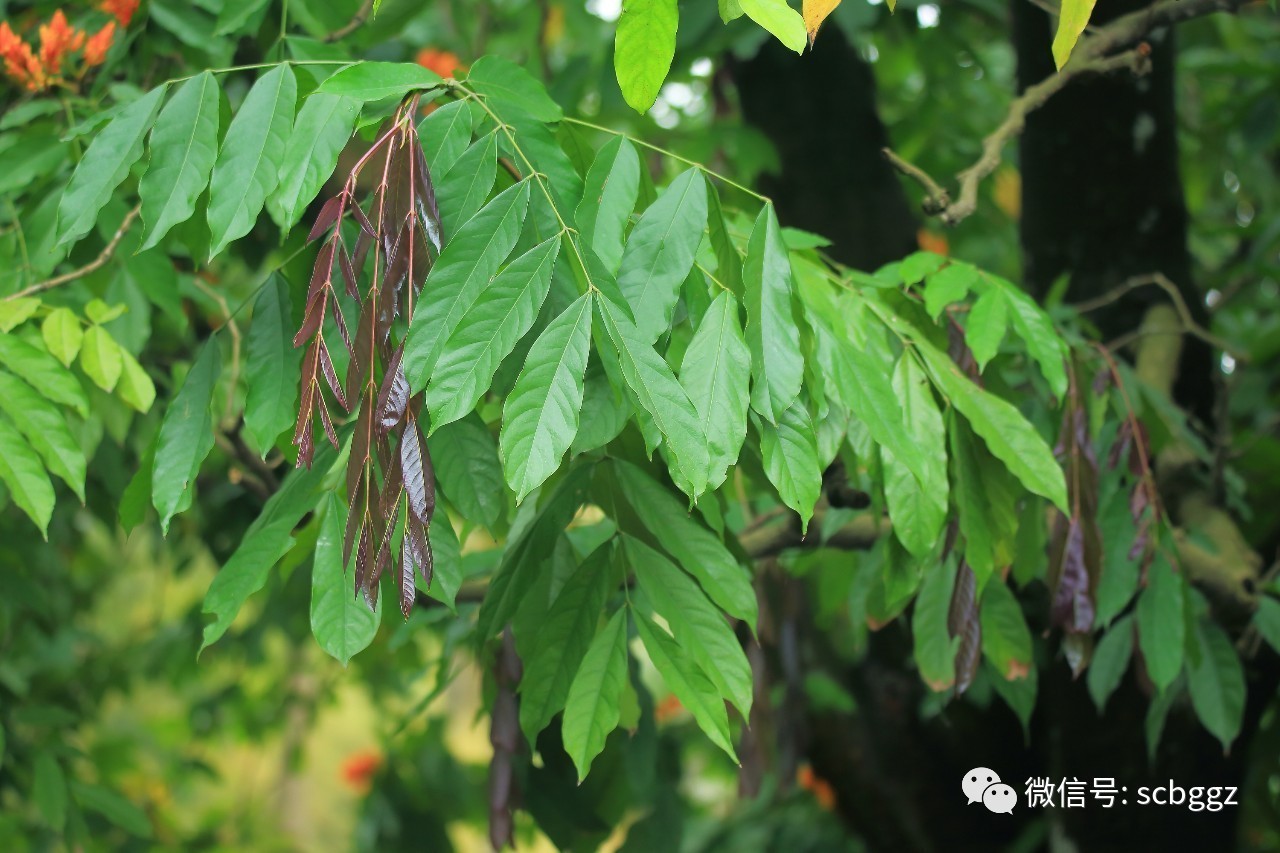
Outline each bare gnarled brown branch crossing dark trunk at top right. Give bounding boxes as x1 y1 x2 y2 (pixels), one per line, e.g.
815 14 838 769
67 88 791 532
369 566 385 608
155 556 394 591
884 0 1248 225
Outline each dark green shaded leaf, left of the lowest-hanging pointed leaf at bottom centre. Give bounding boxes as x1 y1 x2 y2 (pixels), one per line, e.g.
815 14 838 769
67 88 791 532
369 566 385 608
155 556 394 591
520 540 617 743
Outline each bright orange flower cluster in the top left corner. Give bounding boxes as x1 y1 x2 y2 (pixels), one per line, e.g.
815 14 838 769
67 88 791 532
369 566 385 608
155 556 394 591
0 0 138 92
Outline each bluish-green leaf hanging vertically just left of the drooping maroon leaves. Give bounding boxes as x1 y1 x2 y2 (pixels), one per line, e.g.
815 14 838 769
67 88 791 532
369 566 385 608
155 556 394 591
244 273 301 456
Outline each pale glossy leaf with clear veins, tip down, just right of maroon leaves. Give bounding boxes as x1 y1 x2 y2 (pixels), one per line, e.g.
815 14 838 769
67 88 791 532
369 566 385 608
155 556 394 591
500 292 593 502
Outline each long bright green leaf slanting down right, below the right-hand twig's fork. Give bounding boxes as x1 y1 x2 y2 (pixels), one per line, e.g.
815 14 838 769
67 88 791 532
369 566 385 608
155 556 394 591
916 338 1068 512
